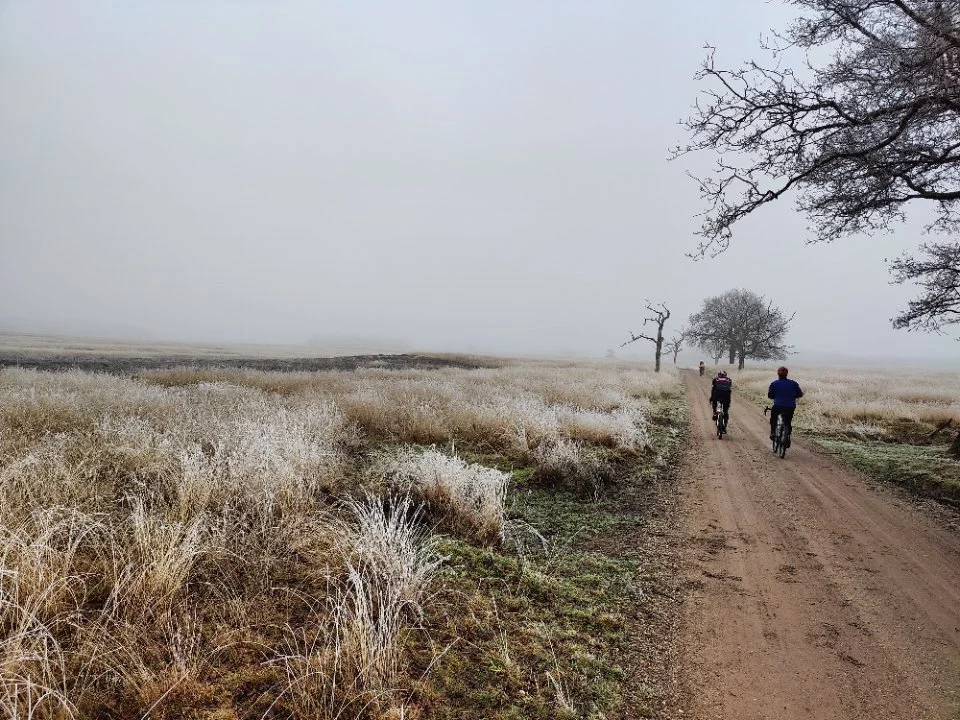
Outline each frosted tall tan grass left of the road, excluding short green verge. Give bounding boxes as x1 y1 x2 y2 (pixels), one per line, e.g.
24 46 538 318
0 363 680 718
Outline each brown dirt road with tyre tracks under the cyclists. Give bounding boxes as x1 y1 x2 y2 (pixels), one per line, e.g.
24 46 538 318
683 373 960 720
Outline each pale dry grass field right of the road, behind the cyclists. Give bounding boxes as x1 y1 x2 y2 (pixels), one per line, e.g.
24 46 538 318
734 367 960 438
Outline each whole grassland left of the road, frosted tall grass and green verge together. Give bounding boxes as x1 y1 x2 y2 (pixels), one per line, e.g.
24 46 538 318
0 361 686 720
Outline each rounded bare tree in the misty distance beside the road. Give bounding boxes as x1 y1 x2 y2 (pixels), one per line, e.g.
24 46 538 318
687 290 794 370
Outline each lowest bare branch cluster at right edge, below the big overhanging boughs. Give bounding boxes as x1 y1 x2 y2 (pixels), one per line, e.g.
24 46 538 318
890 243 960 332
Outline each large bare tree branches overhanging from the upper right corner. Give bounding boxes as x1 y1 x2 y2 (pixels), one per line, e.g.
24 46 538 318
674 0 960 330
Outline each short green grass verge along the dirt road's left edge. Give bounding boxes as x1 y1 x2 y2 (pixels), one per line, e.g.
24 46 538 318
412 388 687 720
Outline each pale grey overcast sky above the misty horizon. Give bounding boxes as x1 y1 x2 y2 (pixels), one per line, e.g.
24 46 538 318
0 0 960 360
